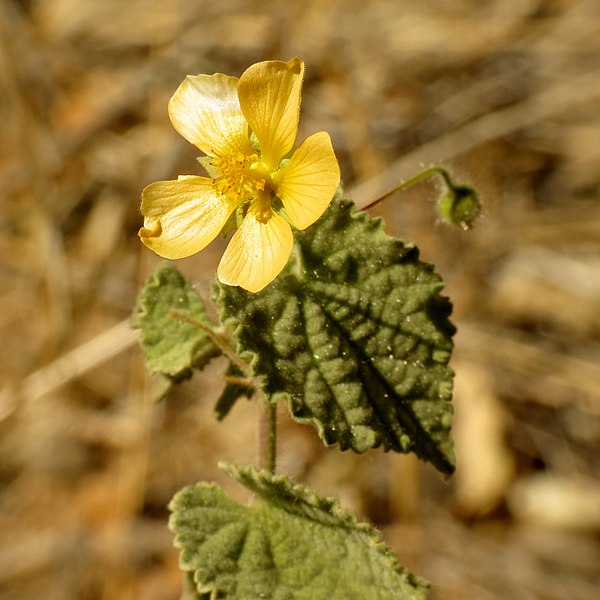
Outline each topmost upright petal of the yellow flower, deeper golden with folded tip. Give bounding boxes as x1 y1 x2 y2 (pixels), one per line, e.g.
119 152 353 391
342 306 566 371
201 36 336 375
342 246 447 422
238 58 304 170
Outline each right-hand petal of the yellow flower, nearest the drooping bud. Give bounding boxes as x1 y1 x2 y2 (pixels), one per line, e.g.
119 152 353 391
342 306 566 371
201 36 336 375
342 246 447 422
276 131 340 229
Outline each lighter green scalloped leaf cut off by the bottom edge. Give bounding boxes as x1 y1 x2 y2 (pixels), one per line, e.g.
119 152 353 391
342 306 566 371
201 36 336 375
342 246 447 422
169 466 428 600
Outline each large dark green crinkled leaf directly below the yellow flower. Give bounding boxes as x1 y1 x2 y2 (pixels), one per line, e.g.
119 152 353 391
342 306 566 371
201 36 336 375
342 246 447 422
215 201 454 474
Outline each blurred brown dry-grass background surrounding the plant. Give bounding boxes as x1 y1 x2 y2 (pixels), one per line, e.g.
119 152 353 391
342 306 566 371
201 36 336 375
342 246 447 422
0 0 600 600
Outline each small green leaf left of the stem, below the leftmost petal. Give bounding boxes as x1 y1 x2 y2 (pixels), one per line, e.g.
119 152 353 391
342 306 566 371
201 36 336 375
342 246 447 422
131 263 220 381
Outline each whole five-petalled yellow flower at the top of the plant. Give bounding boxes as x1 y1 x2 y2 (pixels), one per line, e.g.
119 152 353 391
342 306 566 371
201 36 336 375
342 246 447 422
139 58 340 292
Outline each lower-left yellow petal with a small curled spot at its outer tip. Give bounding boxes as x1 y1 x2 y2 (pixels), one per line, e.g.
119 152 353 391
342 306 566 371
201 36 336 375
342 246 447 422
139 176 236 259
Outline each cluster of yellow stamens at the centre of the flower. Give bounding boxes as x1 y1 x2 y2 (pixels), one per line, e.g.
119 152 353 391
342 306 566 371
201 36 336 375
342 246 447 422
211 152 272 204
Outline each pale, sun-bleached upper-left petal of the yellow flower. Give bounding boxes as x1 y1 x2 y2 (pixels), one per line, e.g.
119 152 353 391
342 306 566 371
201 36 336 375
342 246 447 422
169 73 254 156
